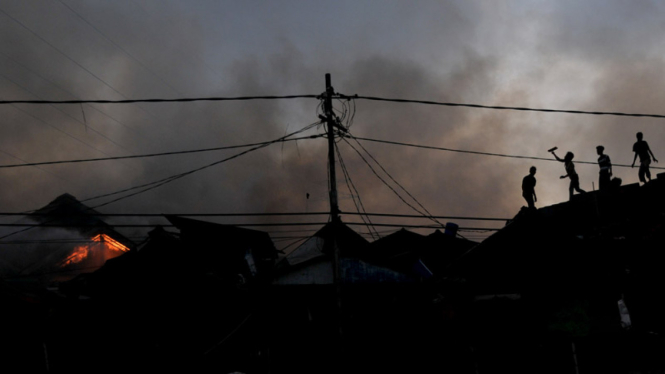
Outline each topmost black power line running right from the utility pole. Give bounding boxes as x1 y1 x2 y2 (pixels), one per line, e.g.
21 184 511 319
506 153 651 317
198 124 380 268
348 95 665 118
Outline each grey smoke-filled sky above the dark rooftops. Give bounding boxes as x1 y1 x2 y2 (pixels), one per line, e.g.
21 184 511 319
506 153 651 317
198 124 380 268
0 0 665 244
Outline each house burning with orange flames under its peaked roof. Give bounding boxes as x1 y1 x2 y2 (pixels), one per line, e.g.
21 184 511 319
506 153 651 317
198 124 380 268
0 194 134 285
